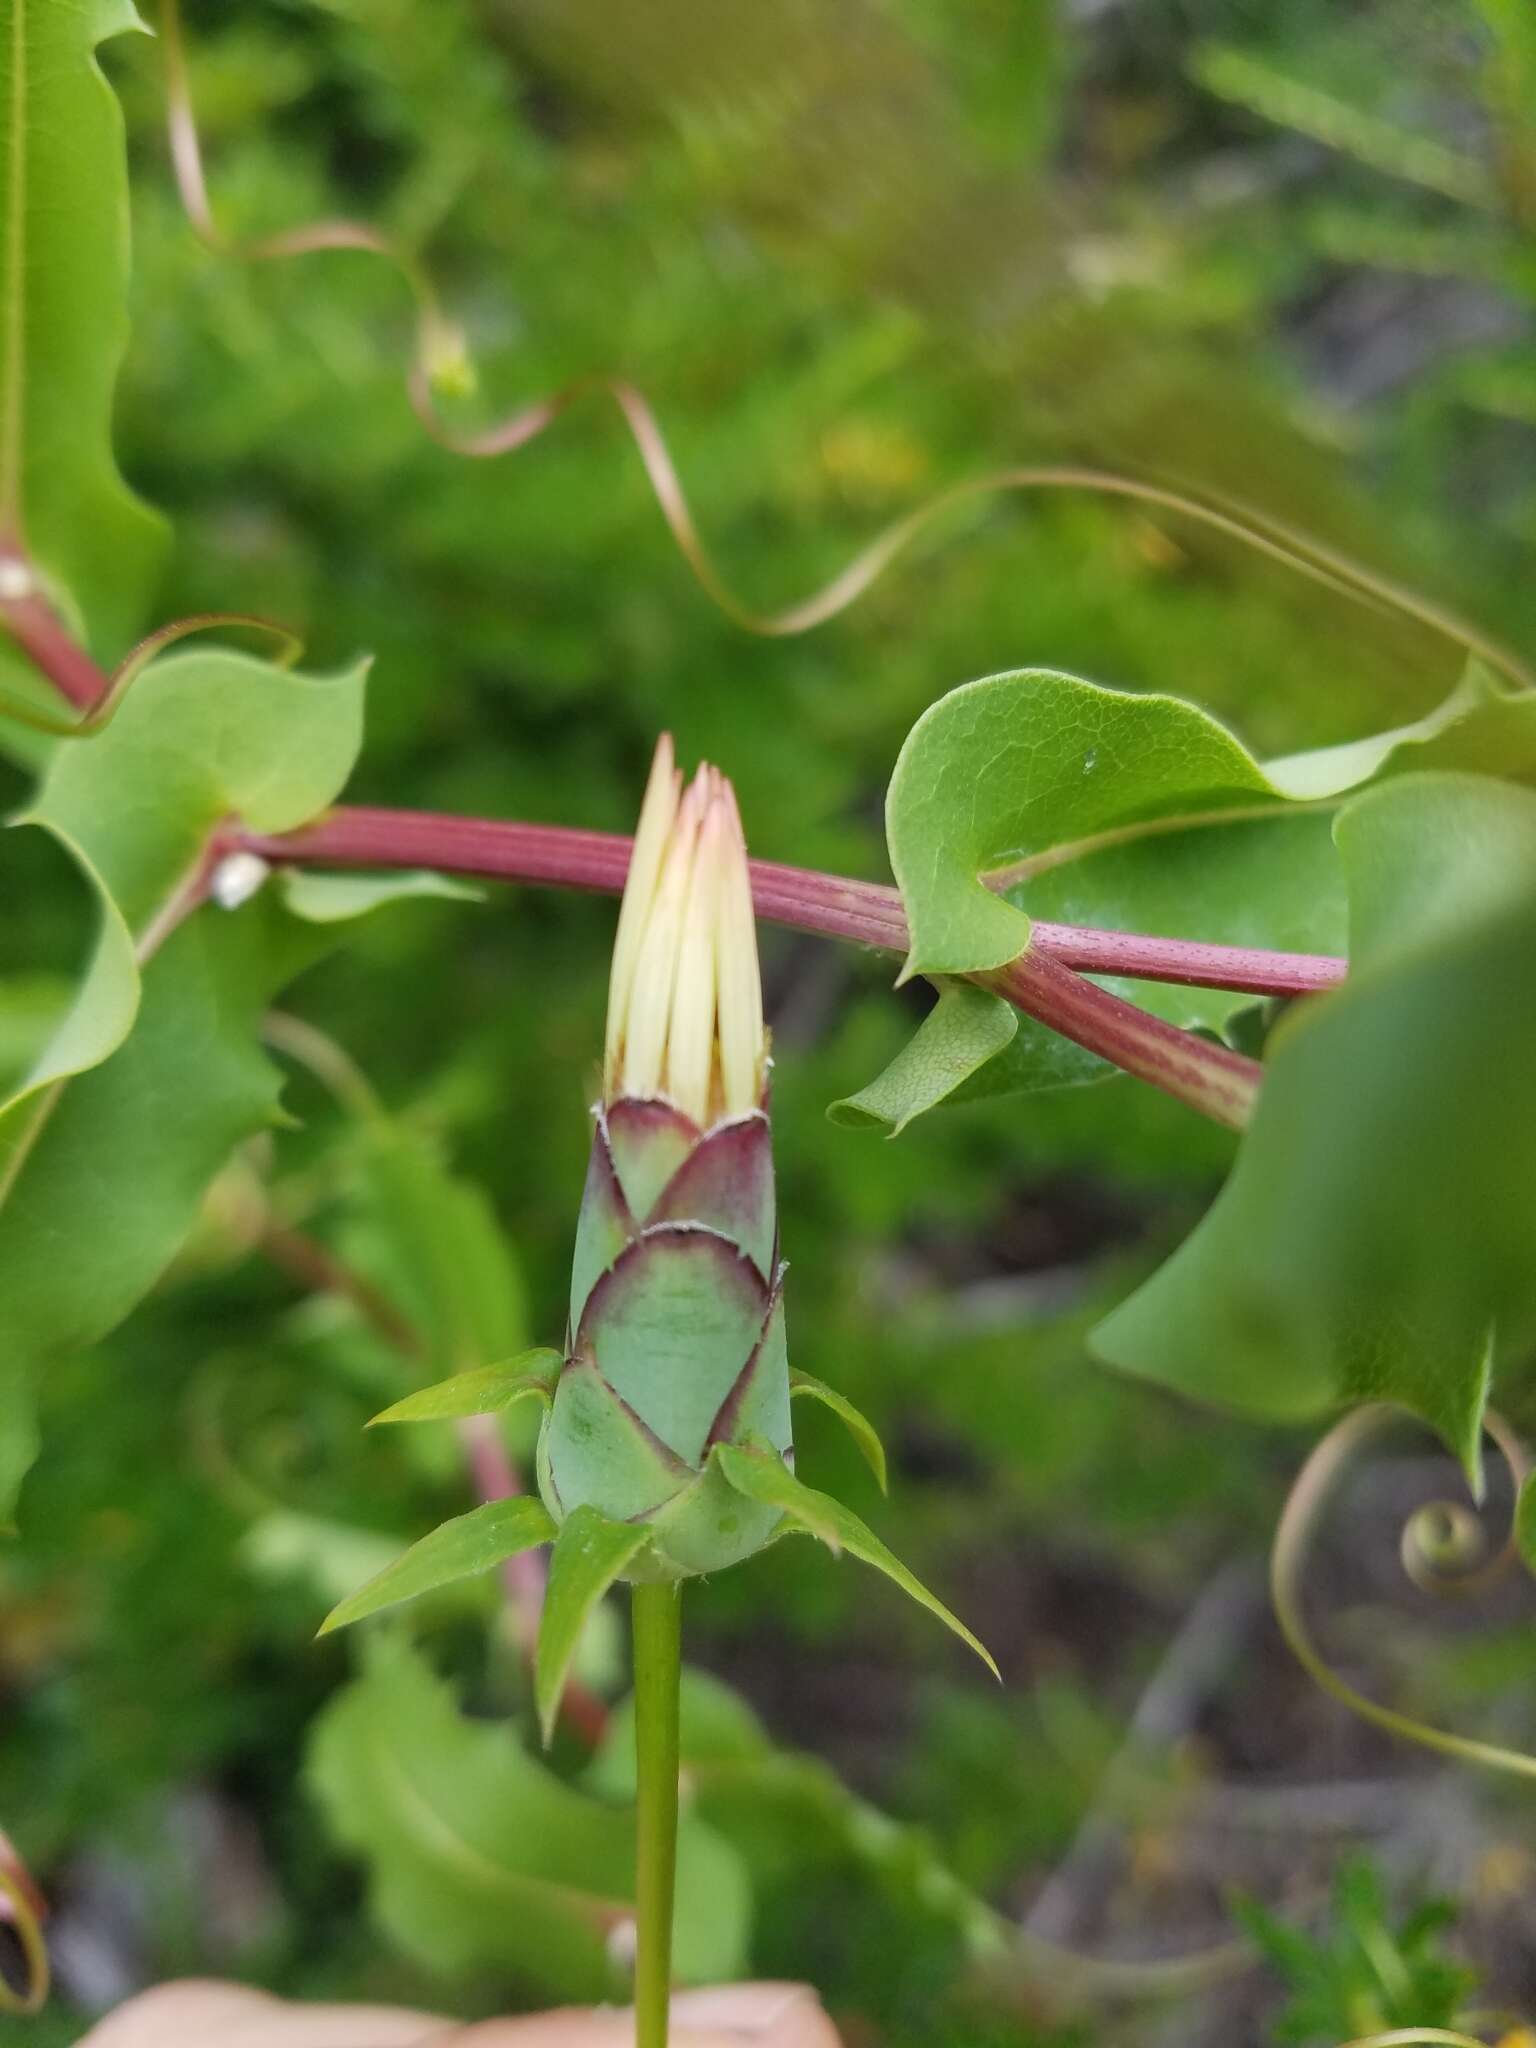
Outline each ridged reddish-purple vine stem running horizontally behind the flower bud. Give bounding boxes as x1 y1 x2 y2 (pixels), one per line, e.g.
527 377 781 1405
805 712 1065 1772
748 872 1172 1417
237 807 1346 995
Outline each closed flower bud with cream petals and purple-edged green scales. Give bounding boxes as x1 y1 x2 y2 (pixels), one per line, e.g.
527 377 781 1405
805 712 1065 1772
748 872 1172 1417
539 739 791 1577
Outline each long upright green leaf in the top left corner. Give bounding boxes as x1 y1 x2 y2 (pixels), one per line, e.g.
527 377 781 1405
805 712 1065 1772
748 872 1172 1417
0 0 164 712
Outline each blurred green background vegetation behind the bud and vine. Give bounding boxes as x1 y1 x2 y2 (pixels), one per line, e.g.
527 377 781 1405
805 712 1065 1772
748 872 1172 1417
0 0 1536 2048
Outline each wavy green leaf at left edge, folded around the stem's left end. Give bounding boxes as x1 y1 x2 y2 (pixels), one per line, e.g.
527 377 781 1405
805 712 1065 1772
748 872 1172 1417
0 651 362 1513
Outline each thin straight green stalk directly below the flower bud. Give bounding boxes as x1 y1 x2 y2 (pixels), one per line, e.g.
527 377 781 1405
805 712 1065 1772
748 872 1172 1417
635 1585 682 2048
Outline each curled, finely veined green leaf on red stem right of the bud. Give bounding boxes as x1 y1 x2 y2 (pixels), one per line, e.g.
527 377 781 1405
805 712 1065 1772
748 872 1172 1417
876 664 1536 1114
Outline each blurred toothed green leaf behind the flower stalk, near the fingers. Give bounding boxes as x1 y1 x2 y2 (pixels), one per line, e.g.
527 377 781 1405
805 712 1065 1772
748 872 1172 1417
307 1630 752 2003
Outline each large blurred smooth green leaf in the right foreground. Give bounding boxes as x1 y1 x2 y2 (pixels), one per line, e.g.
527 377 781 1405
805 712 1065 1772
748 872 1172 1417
1094 776 1536 1483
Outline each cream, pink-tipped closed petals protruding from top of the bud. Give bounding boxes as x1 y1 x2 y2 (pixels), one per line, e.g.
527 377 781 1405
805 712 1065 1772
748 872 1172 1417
602 735 768 1130
